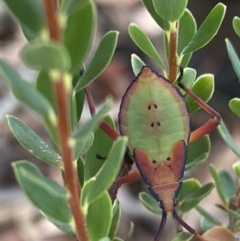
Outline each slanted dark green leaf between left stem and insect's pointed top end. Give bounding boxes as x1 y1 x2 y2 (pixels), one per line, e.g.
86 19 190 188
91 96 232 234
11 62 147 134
75 31 119 91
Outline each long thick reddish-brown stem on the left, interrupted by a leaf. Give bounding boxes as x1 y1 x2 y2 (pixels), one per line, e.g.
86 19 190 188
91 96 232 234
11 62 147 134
44 0 88 241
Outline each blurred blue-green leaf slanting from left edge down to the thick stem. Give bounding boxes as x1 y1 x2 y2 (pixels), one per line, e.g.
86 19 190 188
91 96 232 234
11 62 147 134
0 59 53 118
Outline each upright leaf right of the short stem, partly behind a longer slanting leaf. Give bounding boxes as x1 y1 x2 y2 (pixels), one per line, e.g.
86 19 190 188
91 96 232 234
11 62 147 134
178 9 197 55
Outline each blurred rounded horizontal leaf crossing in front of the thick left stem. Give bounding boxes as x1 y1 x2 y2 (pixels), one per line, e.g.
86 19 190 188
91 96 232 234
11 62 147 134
21 42 71 70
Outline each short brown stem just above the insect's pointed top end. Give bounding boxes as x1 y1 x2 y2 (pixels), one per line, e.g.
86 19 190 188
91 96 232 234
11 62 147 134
168 22 179 83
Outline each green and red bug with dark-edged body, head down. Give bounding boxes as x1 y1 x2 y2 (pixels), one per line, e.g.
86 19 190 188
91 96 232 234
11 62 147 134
119 67 220 241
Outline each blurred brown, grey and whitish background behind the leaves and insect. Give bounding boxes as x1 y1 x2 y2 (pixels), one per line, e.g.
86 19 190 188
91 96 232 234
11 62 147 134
0 0 240 241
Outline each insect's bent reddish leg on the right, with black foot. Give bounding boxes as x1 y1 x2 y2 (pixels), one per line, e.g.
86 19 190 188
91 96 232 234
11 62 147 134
177 68 221 142
